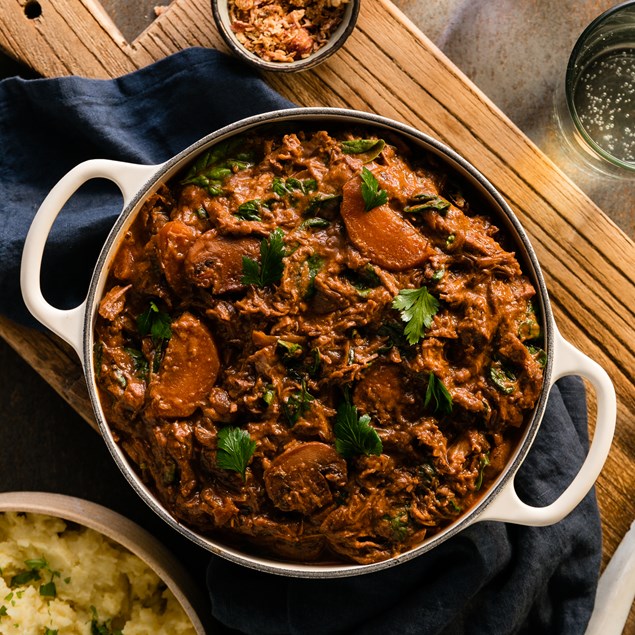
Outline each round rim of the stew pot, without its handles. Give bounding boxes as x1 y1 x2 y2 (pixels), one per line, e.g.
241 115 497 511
82 107 555 578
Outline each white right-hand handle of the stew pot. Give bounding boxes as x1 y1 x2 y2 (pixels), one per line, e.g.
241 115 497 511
479 327 617 526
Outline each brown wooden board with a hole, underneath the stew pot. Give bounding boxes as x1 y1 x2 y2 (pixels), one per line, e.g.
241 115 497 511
0 0 635 632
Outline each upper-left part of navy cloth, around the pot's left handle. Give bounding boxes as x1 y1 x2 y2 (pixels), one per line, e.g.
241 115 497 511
0 48 293 326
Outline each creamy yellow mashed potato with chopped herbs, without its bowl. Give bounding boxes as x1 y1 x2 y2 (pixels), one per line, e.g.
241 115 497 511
0 512 195 635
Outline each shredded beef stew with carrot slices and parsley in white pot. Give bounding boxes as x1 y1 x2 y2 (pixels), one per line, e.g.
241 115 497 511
95 129 545 563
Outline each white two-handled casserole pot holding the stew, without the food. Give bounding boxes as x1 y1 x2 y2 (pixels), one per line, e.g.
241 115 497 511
21 108 616 577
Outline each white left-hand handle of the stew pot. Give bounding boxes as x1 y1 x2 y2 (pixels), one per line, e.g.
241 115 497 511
20 159 161 358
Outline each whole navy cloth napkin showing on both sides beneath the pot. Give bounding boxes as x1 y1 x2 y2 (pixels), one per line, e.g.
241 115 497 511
0 49 601 635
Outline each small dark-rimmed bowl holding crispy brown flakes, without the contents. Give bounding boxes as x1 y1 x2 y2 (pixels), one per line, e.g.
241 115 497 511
212 0 361 73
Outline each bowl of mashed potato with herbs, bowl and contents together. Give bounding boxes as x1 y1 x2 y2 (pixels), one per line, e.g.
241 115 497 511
0 492 206 635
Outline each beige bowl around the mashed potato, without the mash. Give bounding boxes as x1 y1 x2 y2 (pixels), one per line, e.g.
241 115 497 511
0 492 209 635
